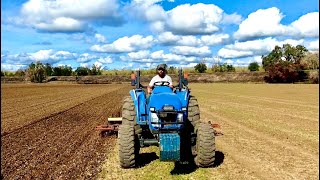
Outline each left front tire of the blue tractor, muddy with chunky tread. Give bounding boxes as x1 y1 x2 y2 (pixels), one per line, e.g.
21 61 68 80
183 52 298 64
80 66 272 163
118 124 139 168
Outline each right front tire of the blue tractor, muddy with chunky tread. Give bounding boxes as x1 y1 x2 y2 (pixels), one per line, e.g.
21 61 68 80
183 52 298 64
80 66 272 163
195 122 216 167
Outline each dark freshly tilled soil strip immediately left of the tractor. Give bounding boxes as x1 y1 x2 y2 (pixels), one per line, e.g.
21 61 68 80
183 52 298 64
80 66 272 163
1 86 130 179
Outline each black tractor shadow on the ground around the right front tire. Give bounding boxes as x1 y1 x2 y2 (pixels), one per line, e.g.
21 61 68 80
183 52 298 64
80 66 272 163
170 151 224 175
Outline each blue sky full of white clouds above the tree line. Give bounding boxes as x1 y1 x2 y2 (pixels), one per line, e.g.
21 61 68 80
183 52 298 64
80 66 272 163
1 0 319 71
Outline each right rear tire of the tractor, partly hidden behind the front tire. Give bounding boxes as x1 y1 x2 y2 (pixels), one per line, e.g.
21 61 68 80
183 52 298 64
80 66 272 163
188 96 200 128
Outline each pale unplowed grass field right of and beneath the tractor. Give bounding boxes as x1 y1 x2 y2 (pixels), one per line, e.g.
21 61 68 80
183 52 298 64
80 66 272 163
98 84 319 179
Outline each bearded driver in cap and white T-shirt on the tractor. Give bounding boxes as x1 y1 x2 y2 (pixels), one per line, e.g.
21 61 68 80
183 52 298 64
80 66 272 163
147 64 173 95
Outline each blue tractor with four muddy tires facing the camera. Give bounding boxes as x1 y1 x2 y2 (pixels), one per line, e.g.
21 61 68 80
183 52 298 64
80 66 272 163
118 69 216 168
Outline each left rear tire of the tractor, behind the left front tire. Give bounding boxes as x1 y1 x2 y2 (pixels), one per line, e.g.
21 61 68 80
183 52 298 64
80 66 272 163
122 96 142 134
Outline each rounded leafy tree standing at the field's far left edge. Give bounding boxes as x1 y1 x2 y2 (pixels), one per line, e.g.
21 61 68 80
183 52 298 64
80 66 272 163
27 61 46 83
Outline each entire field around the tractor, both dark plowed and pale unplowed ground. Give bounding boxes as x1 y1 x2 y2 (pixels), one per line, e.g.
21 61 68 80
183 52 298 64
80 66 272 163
1 84 319 180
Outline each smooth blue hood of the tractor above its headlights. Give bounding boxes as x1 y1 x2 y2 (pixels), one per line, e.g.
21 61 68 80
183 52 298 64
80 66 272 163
149 92 182 110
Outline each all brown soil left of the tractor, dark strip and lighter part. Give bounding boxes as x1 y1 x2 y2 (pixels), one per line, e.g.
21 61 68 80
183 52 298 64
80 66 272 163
1 85 130 179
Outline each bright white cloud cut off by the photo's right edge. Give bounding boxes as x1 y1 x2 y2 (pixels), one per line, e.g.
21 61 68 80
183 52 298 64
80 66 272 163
291 12 319 37
